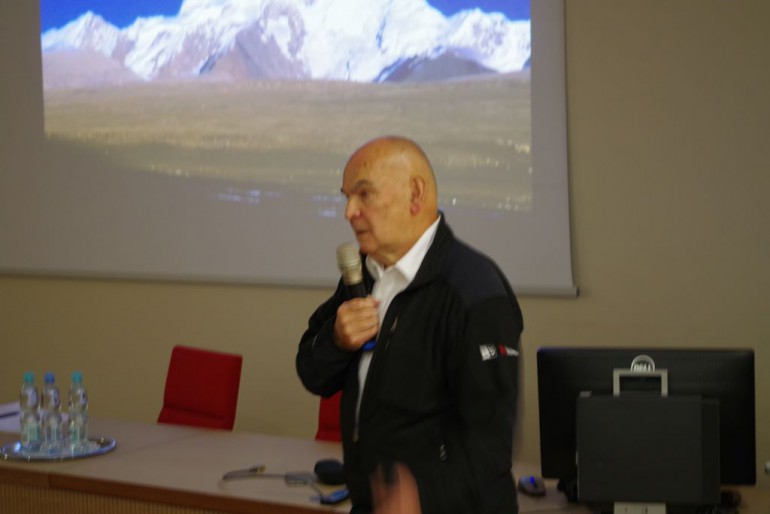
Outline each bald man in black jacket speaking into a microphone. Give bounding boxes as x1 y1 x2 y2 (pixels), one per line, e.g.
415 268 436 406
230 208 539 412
296 136 523 514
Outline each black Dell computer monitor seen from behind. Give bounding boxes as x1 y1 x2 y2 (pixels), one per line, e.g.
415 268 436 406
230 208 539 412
537 347 756 490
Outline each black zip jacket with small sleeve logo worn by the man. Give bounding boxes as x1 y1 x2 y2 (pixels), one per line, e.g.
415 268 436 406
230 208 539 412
296 217 523 514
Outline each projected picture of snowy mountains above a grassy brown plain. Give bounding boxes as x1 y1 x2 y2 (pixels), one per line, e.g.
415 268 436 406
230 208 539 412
41 0 532 210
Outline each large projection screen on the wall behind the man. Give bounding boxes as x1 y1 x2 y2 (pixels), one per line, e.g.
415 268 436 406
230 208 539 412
0 0 576 295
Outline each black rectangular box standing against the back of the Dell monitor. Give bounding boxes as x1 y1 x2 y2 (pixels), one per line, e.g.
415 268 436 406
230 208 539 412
576 394 720 505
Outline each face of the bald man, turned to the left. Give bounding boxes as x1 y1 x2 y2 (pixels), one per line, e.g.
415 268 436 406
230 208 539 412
342 151 411 266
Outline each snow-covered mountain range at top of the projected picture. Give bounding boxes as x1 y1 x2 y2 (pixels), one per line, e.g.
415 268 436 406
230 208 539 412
41 0 530 82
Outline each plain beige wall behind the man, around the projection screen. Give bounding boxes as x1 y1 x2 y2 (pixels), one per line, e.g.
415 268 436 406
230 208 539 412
0 0 770 487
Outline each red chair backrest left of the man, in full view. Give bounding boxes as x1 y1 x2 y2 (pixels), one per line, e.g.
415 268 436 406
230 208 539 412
158 346 243 430
